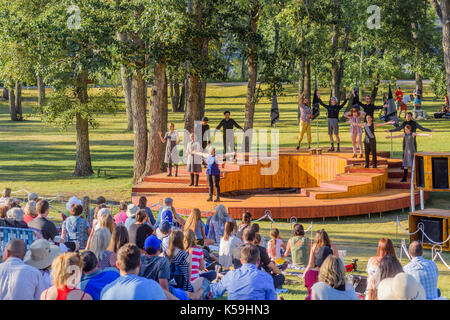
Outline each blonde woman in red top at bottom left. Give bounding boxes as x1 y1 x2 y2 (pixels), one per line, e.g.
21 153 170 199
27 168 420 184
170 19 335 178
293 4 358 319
41 252 92 300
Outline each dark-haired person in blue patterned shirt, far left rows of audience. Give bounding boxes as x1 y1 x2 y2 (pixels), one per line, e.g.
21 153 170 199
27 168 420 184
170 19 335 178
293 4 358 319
61 204 91 249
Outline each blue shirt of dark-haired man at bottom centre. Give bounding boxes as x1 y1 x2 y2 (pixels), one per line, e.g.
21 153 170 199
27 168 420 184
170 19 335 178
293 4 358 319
211 263 277 300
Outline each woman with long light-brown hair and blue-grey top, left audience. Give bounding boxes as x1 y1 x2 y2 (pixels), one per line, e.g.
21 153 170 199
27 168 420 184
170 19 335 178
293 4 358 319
86 228 116 270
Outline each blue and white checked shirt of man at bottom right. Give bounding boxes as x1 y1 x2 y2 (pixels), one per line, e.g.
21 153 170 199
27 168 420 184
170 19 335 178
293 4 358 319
403 257 439 300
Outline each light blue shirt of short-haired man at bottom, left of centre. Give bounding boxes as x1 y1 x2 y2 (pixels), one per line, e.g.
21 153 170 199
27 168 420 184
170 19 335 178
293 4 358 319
101 274 166 300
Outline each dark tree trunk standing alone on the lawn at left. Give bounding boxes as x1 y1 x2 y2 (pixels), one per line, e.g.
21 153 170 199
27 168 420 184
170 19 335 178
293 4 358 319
73 71 94 177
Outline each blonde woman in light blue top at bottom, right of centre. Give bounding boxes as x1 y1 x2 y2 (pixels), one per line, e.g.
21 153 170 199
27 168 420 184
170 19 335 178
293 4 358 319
311 255 358 300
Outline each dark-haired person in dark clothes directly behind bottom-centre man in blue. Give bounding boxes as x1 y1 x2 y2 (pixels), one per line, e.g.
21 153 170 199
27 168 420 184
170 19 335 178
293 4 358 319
232 228 285 289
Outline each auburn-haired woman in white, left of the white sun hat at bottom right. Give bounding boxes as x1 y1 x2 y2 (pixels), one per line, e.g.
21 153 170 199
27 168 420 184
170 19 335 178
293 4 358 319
366 238 396 300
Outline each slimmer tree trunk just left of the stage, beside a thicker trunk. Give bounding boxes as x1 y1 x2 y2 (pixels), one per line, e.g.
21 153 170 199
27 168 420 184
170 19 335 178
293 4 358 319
131 72 148 183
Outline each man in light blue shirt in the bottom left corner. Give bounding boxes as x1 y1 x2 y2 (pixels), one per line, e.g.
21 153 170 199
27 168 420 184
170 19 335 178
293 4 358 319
0 239 45 300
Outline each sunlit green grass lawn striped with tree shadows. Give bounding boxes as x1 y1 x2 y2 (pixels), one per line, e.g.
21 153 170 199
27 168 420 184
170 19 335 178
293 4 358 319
0 84 450 299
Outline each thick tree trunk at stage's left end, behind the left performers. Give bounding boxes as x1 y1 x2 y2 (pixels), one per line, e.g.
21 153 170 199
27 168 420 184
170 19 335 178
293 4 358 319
145 62 169 175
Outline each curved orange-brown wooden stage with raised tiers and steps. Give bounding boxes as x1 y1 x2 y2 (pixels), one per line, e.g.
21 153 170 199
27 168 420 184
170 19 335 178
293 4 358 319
132 148 427 219
